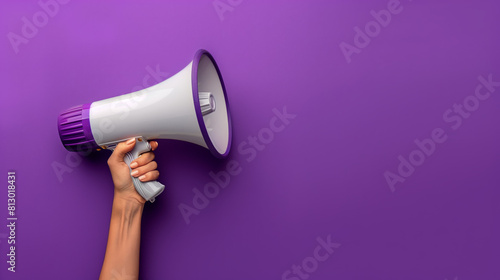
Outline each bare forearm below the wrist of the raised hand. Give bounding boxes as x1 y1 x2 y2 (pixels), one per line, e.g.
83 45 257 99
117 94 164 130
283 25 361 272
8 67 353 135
99 193 144 280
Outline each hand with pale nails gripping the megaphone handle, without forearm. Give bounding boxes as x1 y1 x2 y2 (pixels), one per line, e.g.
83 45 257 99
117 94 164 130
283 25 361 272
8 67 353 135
108 138 160 204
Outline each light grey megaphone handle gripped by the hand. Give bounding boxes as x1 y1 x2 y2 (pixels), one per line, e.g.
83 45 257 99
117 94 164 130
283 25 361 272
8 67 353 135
124 137 165 202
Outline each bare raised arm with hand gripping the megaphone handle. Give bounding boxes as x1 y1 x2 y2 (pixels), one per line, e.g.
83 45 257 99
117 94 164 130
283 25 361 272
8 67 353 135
99 138 159 280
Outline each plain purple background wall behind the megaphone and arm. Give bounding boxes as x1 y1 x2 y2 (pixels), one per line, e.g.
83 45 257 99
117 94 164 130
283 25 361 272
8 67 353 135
0 0 500 280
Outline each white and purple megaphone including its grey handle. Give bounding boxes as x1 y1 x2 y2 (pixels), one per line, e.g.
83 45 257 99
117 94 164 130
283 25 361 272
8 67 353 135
57 50 231 202
